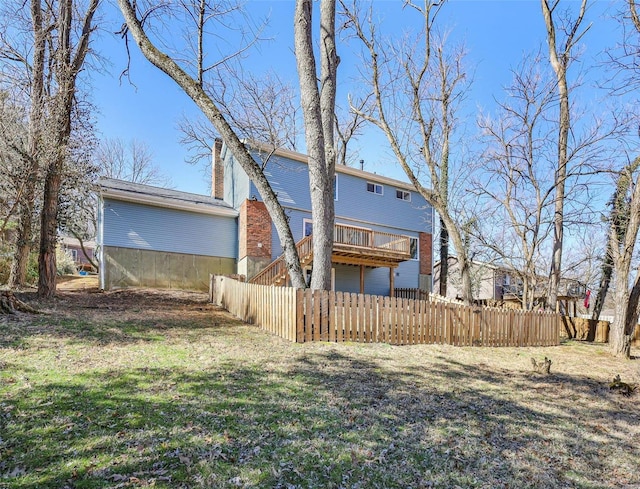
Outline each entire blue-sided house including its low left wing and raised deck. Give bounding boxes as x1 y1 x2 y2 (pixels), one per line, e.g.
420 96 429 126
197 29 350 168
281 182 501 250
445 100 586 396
99 142 433 295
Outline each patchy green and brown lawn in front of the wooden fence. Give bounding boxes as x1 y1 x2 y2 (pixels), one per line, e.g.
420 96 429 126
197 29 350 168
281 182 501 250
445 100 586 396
0 284 640 489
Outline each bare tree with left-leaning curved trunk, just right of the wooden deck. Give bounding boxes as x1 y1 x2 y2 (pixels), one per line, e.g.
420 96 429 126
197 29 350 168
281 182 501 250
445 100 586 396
345 1 473 302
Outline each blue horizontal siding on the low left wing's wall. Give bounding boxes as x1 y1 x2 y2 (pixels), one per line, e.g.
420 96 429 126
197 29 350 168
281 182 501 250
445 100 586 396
103 199 237 258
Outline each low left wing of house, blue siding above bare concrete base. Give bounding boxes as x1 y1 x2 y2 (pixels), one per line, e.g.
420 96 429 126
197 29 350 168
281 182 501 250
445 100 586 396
98 179 238 290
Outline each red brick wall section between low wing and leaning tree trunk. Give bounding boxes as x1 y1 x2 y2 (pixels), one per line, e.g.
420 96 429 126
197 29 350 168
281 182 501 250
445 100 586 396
238 200 271 260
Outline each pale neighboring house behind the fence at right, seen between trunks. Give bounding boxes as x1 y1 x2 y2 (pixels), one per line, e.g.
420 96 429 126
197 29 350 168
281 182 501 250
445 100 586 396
433 256 587 316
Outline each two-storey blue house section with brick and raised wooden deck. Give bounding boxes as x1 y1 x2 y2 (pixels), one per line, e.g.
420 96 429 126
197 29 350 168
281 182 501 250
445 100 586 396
212 143 433 295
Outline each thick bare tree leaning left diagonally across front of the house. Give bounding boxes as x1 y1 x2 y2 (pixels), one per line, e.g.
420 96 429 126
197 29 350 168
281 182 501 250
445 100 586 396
118 0 311 288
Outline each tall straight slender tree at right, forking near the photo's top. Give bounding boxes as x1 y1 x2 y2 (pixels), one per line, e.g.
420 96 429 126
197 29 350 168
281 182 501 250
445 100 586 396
541 0 588 308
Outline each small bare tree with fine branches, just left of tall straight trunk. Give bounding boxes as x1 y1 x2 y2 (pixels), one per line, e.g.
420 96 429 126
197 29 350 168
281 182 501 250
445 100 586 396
473 52 557 309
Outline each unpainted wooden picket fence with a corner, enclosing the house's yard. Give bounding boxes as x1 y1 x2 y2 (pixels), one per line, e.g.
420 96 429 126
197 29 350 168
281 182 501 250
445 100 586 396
211 277 561 346
